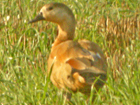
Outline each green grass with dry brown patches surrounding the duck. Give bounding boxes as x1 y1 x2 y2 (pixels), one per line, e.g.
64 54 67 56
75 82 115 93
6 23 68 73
0 0 140 105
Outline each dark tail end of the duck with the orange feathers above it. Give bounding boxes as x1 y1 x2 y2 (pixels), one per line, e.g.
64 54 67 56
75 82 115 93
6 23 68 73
67 58 107 87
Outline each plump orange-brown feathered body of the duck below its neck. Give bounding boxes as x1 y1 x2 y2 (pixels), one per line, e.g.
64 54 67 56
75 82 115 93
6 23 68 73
48 40 106 94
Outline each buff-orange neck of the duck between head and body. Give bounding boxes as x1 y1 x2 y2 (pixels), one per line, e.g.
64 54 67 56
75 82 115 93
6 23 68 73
53 18 75 46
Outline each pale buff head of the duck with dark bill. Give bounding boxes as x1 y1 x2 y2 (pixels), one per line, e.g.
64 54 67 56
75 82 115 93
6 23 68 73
29 3 74 24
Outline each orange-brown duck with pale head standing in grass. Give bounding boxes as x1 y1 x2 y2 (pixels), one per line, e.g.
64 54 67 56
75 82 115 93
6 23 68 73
29 2 107 99
